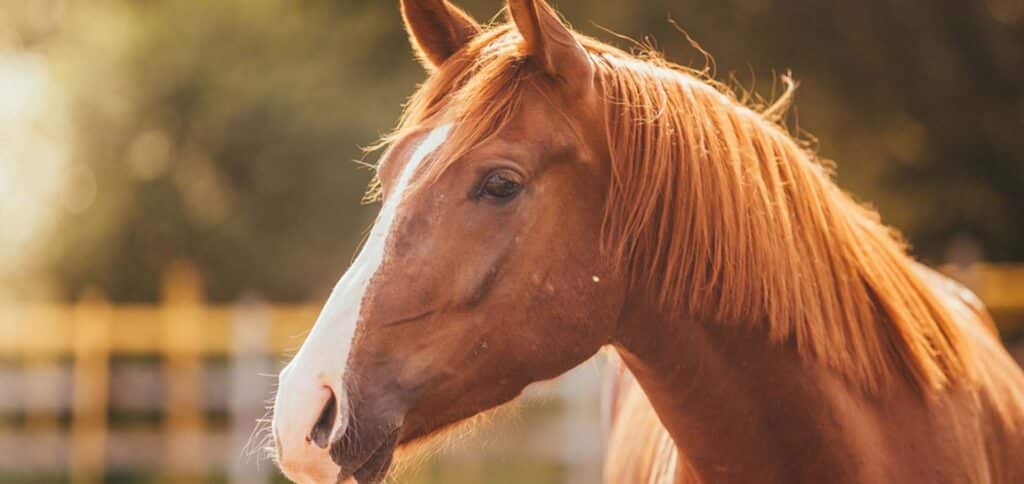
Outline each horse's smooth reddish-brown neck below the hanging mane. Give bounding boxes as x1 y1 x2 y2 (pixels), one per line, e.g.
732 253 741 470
615 307 909 482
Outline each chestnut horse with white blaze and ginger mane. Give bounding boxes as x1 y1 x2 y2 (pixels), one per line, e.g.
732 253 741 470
271 0 1024 483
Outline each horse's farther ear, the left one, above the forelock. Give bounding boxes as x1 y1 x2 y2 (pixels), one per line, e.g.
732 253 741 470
401 0 480 71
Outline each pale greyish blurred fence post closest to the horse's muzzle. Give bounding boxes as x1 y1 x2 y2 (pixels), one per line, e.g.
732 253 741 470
230 296 274 484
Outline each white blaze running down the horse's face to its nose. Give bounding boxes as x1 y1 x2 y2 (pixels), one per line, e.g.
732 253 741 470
272 125 451 473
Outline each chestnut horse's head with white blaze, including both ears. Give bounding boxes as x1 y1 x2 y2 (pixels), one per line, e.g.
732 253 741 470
273 0 626 482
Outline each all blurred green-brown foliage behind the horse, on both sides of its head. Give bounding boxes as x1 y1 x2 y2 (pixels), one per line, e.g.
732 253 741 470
39 0 1024 300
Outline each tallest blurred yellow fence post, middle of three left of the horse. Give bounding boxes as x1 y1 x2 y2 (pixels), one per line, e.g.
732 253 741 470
161 261 207 478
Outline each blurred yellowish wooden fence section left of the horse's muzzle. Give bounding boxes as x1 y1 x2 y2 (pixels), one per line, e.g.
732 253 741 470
0 264 318 482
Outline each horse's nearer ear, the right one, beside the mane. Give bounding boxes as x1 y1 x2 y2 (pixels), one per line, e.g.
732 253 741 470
509 0 594 79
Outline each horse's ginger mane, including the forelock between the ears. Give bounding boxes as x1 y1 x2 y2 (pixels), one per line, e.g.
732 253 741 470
381 25 970 391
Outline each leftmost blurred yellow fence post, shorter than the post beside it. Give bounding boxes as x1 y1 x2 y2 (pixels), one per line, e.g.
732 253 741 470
69 290 113 483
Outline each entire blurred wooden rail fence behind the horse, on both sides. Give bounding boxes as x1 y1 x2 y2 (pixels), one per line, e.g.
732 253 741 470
0 263 1024 482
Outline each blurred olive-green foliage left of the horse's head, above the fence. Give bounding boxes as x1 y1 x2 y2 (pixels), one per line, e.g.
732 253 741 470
49 0 417 300
